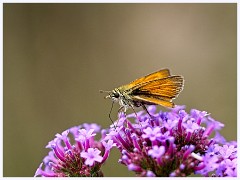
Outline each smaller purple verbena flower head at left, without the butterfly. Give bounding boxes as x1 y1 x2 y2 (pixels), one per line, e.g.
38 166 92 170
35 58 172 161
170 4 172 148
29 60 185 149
35 123 115 177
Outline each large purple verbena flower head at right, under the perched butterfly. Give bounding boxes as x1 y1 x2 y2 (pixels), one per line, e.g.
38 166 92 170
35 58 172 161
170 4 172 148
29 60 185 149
105 106 237 177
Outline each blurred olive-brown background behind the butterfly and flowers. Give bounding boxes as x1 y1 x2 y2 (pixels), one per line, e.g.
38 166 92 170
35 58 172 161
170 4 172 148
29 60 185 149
3 4 237 176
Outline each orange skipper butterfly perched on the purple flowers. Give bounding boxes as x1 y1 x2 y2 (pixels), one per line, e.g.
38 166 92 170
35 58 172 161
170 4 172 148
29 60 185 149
100 69 184 119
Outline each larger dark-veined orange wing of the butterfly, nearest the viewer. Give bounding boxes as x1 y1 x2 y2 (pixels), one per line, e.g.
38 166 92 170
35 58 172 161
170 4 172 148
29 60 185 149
131 76 184 107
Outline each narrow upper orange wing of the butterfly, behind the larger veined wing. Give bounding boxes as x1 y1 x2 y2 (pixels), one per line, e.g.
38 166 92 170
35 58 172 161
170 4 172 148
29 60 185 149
121 69 170 90
